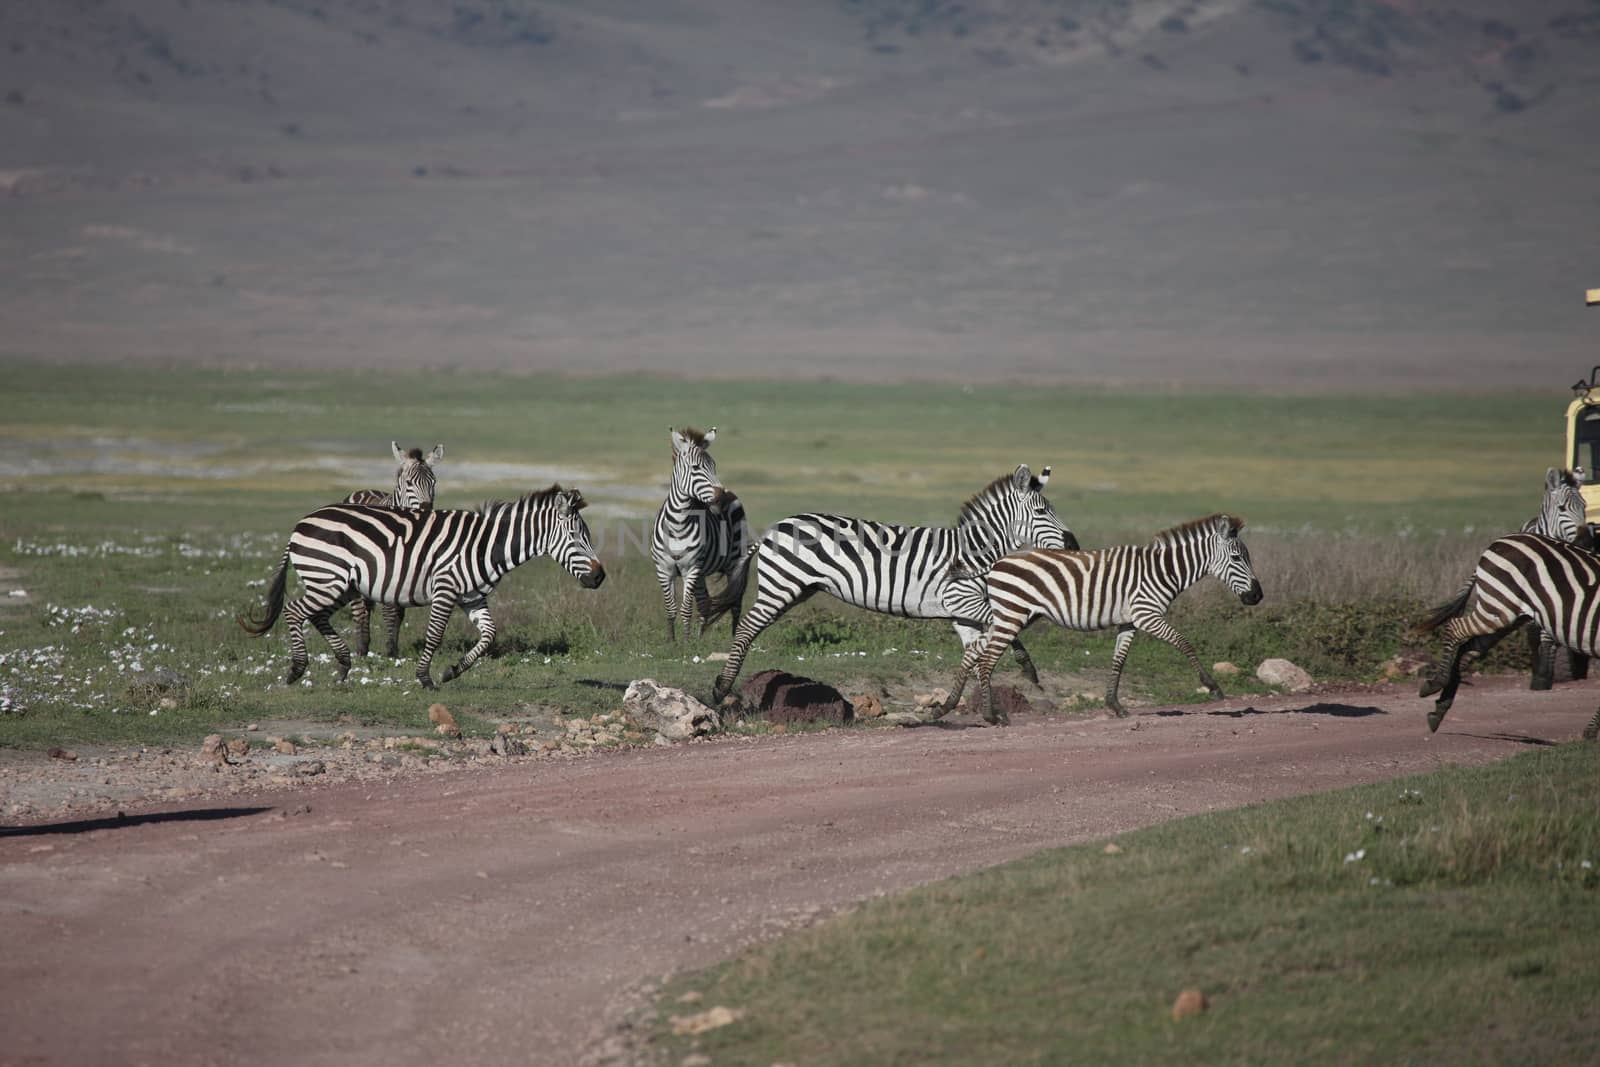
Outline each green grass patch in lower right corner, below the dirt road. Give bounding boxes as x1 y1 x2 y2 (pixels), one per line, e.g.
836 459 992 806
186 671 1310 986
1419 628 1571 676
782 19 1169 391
658 744 1600 1067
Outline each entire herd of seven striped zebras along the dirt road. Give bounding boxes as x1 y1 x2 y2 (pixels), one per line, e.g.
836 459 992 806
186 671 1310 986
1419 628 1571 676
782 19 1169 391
240 427 1600 737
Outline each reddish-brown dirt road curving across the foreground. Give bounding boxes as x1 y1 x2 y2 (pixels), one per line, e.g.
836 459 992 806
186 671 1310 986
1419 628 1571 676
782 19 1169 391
0 678 1600 1064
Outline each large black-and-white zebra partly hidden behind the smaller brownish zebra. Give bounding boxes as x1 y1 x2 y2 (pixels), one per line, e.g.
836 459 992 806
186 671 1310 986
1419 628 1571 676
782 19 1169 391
704 464 1078 702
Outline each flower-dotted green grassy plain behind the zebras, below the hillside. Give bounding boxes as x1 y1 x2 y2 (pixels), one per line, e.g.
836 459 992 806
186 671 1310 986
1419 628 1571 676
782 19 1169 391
0 365 1560 745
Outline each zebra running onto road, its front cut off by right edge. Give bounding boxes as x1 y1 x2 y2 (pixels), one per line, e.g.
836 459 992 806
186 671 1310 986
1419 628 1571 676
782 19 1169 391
1416 533 1600 741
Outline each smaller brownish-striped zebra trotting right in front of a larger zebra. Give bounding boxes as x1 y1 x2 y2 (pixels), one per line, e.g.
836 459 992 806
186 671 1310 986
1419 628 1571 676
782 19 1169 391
934 514 1261 723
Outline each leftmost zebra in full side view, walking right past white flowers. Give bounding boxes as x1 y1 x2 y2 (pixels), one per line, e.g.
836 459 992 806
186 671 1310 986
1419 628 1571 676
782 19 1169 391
238 485 605 689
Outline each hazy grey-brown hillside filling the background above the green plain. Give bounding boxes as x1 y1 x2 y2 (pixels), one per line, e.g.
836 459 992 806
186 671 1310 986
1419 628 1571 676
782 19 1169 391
0 0 1600 389
